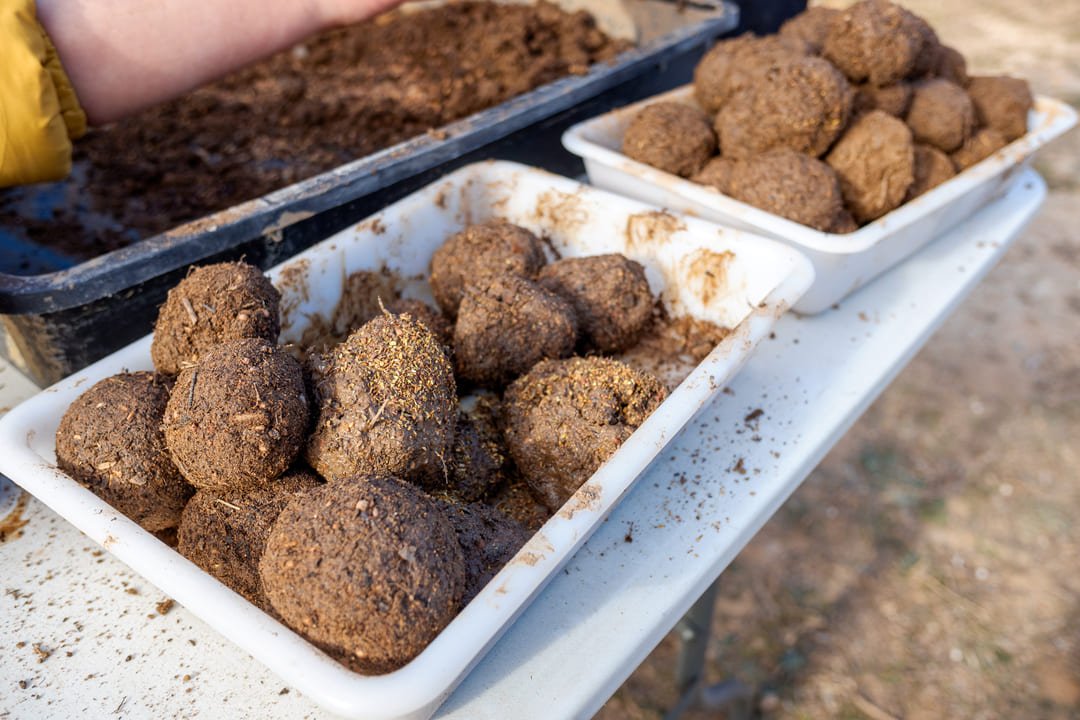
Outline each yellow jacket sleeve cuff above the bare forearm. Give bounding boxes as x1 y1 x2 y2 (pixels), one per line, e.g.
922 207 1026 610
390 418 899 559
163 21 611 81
0 0 86 188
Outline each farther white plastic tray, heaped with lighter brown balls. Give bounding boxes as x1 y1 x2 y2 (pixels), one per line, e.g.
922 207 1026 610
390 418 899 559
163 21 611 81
563 85 1077 314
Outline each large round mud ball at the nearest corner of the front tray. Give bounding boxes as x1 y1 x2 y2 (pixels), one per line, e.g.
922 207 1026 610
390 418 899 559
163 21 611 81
259 476 465 675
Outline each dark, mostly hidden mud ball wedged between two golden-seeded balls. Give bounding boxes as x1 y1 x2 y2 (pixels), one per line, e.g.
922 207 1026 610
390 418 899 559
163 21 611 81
446 400 508 502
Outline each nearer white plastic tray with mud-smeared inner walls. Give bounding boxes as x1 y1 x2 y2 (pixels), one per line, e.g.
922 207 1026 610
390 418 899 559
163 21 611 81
0 163 813 719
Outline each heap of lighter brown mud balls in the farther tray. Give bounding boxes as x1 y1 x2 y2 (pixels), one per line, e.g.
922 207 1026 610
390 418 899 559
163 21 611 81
622 0 1032 233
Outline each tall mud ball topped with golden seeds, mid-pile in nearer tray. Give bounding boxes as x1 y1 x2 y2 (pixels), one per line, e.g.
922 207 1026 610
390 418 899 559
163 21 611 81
306 315 458 487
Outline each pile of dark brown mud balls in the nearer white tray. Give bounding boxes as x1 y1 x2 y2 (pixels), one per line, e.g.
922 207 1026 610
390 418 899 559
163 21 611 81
56 220 666 674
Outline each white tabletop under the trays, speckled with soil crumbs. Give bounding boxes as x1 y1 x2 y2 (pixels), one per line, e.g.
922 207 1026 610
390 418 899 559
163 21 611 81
0 172 1045 720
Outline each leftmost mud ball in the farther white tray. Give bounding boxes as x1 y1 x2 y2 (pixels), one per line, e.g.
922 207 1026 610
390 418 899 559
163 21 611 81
622 103 716 177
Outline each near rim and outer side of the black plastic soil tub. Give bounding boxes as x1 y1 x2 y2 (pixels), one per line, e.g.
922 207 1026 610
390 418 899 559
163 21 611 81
0 4 739 385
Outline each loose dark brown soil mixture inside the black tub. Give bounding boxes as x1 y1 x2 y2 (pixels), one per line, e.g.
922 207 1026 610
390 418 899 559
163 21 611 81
0 2 627 258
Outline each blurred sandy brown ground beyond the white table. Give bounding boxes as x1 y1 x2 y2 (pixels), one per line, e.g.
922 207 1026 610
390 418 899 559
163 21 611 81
598 0 1080 720
